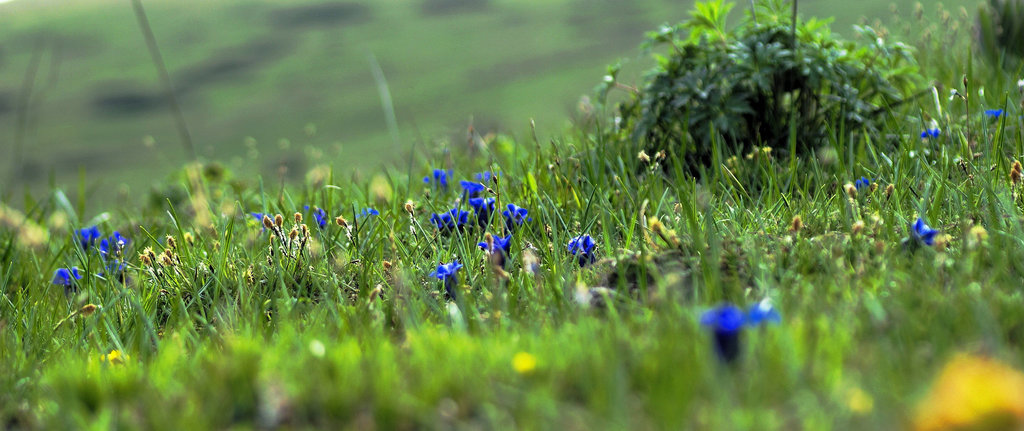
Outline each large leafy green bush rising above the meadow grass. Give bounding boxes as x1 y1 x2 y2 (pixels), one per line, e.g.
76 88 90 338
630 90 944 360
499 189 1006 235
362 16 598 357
598 0 923 172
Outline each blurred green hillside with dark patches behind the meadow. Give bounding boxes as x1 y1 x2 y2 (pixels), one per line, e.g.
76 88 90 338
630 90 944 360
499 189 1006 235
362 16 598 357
0 0 974 198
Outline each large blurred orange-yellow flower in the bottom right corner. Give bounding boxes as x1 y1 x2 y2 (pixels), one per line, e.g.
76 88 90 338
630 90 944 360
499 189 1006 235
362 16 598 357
913 354 1024 431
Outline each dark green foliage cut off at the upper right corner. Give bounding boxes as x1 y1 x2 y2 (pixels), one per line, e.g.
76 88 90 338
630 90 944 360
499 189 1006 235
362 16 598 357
978 0 1024 67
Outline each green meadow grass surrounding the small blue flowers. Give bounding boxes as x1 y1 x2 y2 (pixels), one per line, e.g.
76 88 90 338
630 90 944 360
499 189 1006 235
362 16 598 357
0 0 1024 429
